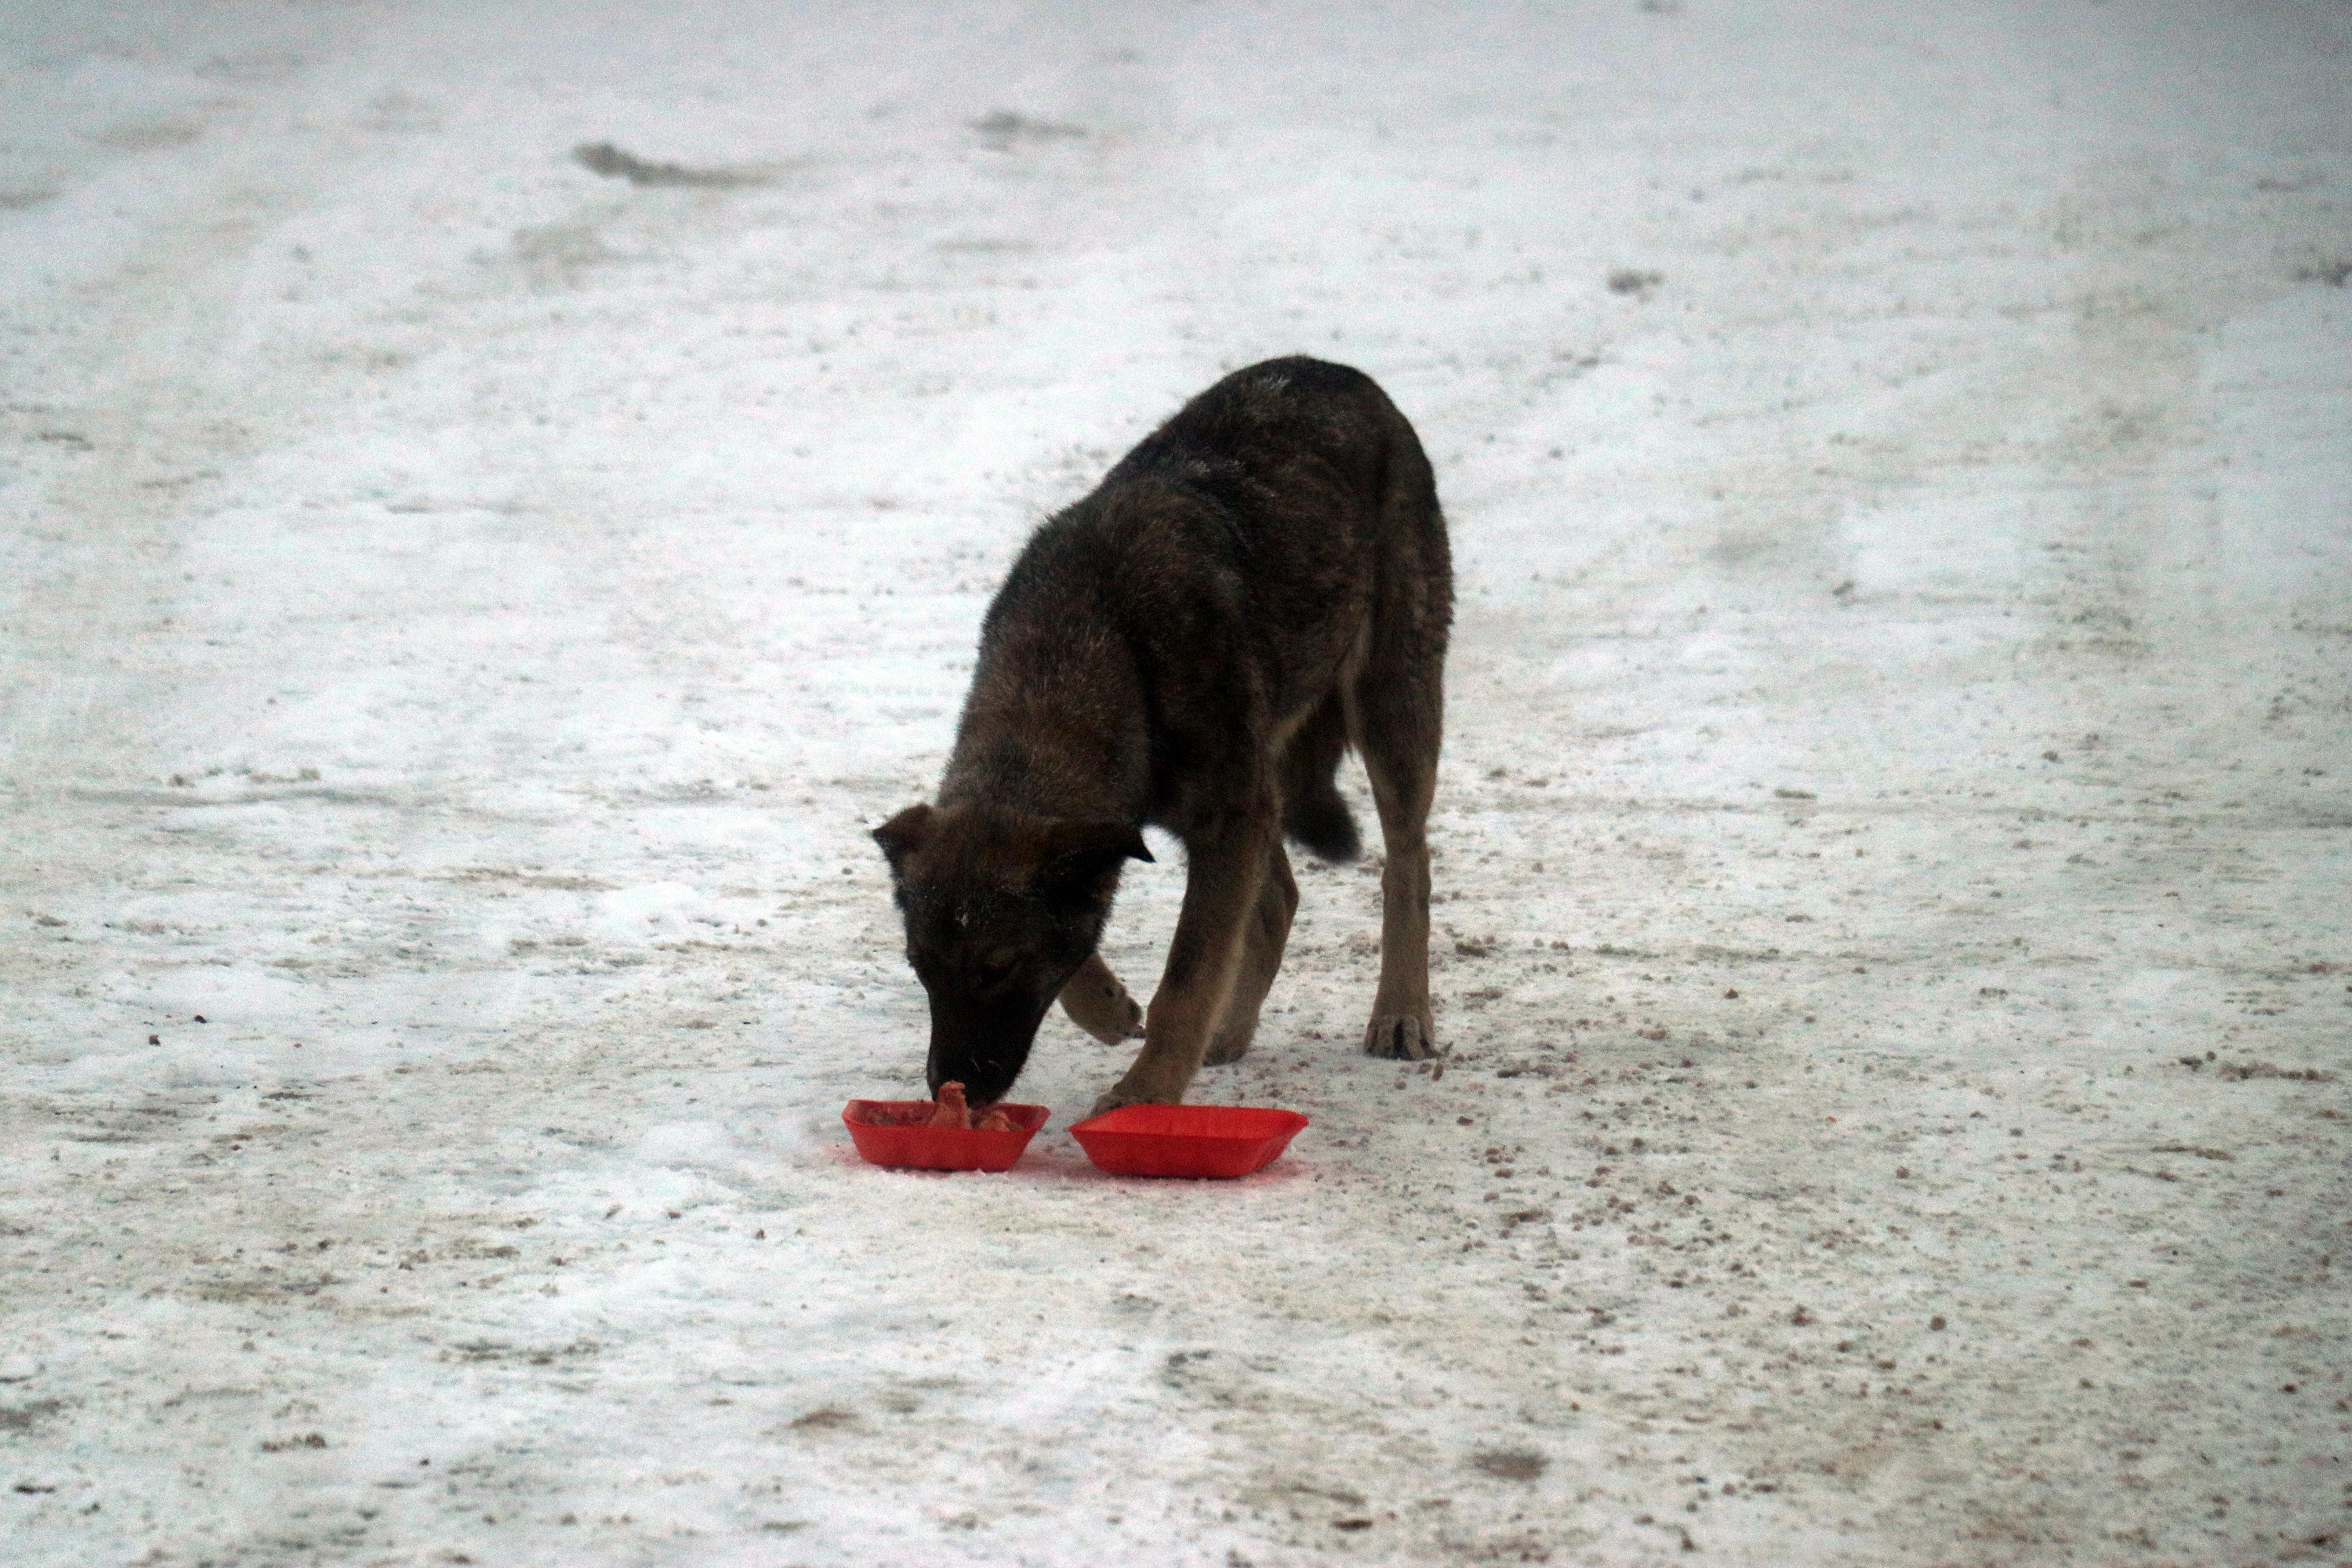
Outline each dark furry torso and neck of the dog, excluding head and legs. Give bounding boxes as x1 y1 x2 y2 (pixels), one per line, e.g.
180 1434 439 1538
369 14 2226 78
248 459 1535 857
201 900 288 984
941 358 1454 858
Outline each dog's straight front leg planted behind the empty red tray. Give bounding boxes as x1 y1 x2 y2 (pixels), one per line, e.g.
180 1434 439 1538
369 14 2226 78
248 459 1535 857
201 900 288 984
1094 809 1277 1114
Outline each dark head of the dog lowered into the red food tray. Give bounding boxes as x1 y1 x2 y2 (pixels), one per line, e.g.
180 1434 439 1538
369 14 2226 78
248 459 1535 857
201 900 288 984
875 804 1152 1105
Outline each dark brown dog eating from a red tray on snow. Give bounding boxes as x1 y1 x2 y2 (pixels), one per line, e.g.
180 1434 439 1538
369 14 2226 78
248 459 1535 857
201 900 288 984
873 358 1454 1112
